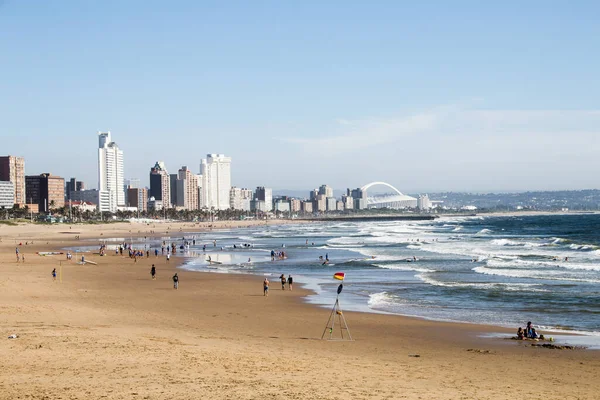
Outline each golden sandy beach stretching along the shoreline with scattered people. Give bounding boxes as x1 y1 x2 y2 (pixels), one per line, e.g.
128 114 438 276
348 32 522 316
0 221 600 399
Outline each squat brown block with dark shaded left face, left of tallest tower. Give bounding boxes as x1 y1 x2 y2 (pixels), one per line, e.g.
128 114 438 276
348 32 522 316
25 173 65 213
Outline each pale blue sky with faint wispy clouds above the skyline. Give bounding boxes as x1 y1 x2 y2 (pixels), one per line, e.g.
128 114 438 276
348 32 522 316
0 0 600 192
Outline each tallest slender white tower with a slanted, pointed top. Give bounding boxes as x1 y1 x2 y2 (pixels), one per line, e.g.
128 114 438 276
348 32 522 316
98 132 125 212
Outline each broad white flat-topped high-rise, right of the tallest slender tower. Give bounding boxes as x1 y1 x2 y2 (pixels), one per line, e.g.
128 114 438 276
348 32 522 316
200 154 231 210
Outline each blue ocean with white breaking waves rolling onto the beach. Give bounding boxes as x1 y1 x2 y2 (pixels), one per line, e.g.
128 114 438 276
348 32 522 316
76 214 600 336
